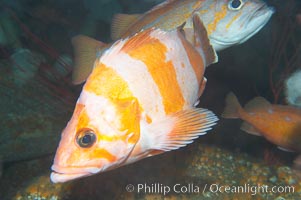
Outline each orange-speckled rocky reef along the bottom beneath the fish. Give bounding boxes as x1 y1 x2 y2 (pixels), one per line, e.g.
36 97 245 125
0 143 301 200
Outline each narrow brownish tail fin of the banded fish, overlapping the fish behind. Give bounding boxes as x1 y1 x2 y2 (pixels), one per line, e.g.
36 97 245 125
193 14 218 66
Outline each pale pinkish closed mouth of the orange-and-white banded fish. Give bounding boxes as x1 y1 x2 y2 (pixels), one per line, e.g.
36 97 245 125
50 165 101 183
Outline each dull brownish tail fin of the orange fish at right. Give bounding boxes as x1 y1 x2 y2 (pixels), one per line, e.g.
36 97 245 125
222 92 242 119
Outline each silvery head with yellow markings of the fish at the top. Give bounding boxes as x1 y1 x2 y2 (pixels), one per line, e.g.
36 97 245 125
196 0 274 51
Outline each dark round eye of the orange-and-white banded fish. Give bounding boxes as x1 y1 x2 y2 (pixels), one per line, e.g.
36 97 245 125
76 129 96 148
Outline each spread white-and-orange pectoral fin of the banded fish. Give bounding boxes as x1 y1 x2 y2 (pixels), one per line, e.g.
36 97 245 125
148 108 218 152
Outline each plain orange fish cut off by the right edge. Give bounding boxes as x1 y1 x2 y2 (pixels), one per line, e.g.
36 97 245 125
222 93 301 167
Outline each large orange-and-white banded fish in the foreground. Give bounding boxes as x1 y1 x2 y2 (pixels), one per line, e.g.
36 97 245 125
51 17 218 182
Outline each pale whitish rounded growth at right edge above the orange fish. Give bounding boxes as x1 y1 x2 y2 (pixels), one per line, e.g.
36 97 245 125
284 70 301 108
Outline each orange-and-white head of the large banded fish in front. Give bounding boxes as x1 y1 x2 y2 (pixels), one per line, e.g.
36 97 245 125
51 91 140 183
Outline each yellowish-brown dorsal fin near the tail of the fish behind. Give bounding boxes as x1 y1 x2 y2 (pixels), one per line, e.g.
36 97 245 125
111 14 142 40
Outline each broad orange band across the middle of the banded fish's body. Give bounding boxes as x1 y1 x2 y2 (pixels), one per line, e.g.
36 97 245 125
124 33 184 114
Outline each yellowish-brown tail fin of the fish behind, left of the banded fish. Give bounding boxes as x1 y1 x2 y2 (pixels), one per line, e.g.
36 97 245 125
72 35 107 85
